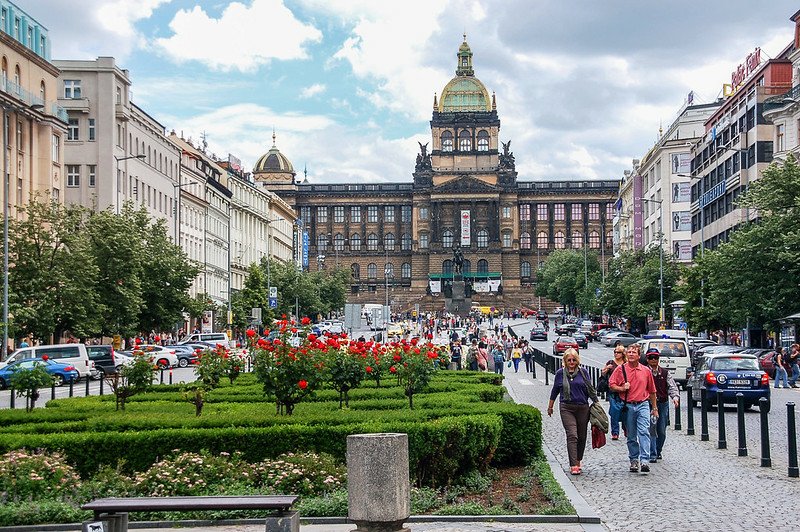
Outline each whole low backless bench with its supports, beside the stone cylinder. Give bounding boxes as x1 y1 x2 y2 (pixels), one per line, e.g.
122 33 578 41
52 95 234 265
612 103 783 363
81 495 300 532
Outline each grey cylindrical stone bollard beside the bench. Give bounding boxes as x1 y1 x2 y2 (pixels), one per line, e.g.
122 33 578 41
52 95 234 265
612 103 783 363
347 434 411 532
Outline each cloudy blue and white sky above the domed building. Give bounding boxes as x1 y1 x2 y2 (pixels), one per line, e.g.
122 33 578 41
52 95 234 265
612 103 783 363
15 0 798 183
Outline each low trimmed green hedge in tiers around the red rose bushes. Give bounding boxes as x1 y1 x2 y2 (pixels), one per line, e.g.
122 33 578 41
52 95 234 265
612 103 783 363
0 372 541 486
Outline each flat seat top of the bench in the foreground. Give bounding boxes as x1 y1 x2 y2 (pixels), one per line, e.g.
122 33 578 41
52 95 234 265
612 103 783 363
81 495 298 513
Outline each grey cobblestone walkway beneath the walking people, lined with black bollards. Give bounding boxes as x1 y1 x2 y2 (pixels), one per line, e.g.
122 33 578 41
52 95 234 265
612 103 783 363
505 331 800 532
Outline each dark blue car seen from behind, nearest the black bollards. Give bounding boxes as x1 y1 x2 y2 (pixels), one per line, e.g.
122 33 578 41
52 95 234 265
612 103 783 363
689 353 770 412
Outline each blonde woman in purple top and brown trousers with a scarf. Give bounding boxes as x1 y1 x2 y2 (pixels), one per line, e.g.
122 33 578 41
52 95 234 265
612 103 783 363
547 348 597 475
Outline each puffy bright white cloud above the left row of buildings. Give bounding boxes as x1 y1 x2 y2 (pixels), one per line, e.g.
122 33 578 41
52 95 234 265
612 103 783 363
155 0 322 72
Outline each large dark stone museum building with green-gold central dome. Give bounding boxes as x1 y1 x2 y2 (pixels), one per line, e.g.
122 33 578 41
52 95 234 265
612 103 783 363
253 39 619 312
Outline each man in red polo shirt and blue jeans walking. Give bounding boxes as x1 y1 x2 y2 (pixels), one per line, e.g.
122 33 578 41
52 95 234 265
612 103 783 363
608 344 658 474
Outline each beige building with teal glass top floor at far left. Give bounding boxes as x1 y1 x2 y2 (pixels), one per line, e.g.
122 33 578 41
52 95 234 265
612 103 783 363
0 1 67 217
